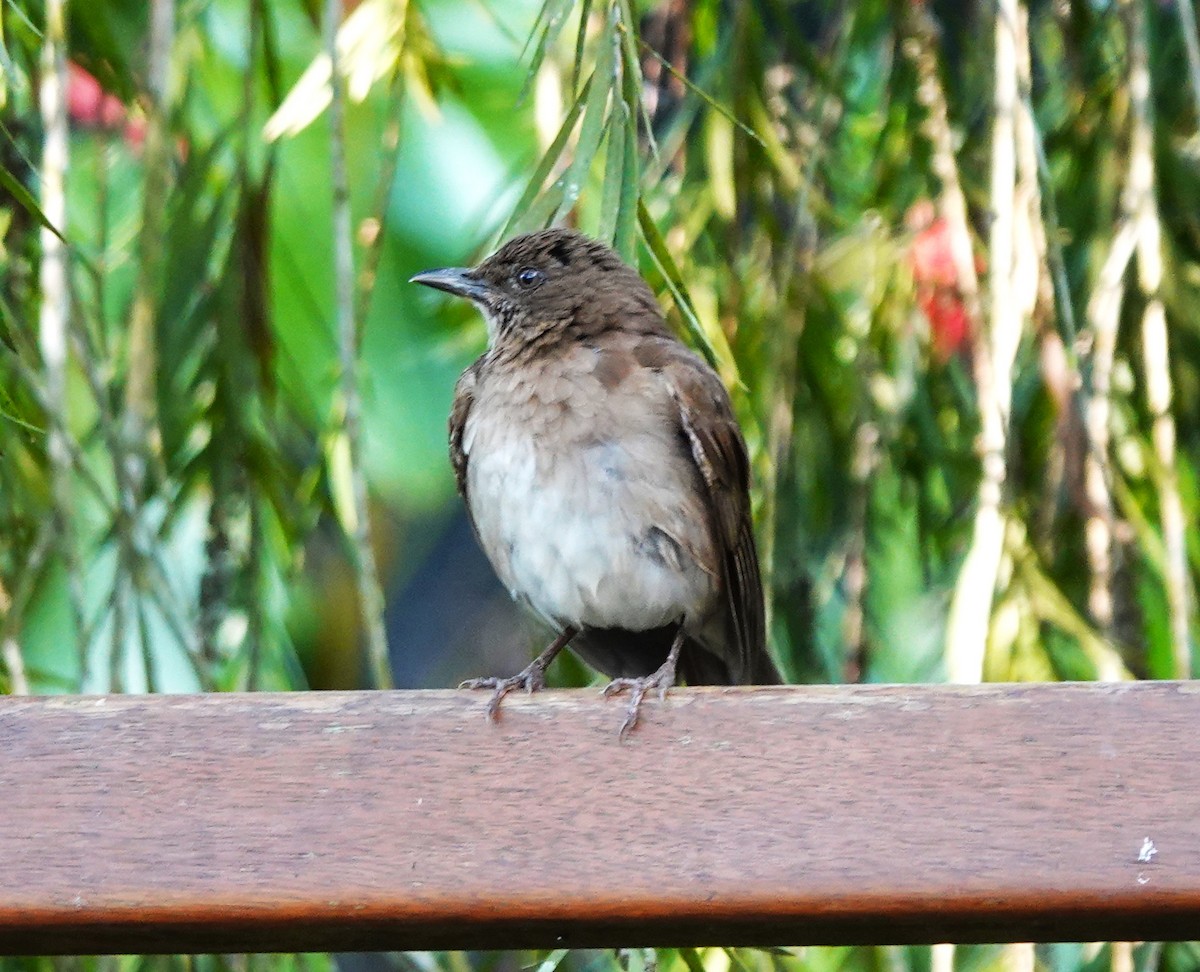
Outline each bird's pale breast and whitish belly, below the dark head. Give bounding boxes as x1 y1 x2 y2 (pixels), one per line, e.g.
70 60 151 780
463 353 718 630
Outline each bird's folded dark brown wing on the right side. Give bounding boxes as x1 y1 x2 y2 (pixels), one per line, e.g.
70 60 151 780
647 340 779 682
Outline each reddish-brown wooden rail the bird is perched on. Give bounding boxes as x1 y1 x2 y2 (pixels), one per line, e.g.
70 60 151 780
0 683 1200 954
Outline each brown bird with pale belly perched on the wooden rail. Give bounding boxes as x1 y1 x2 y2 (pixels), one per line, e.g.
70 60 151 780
413 229 780 736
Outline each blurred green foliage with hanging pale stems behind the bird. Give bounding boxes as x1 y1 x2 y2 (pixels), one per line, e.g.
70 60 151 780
0 0 1200 972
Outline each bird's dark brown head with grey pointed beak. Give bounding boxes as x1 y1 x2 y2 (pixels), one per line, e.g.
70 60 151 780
412 229 662 347
